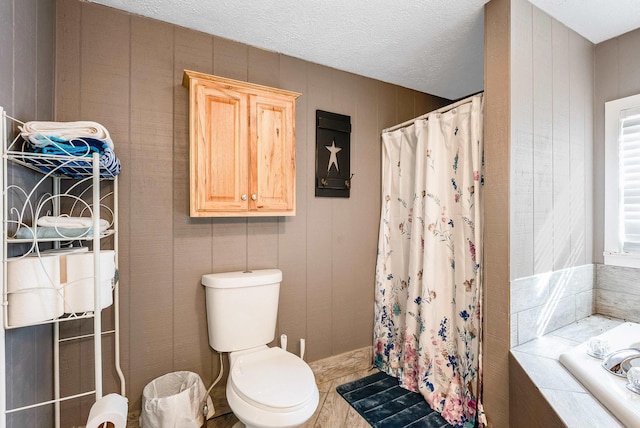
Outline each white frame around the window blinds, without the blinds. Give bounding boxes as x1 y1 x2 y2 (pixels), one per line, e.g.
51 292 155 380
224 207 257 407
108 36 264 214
604 94 640 268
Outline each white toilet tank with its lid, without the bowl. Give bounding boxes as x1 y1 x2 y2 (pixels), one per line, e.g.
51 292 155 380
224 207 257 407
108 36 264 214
202 269 282 352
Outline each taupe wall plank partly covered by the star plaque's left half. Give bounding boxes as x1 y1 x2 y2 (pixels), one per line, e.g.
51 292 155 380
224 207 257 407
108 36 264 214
300 63 337 361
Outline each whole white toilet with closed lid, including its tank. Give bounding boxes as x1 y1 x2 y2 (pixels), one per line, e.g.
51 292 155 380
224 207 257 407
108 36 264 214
202 269 319 428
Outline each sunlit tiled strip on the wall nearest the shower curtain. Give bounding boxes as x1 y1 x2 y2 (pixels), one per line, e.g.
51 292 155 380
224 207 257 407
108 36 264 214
511 264 596 347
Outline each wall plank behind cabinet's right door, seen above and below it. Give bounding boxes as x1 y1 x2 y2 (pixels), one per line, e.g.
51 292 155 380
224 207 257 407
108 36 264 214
247 47 280 269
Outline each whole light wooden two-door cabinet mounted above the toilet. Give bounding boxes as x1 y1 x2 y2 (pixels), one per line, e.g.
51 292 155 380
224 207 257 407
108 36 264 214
182 70 300 217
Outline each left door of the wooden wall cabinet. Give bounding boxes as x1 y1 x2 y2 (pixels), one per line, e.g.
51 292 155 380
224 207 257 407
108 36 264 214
190 82 249 217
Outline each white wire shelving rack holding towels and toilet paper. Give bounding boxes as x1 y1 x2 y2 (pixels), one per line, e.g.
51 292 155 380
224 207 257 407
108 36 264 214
0 107 126 428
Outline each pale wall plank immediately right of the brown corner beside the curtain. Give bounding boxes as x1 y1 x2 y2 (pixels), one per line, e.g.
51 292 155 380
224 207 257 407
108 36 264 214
510 0 534 279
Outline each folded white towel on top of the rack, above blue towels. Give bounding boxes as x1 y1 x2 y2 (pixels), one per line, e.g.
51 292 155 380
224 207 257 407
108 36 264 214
19 121 114 150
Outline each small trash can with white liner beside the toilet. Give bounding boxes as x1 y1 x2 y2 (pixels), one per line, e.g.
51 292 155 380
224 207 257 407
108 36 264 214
140 371 214 428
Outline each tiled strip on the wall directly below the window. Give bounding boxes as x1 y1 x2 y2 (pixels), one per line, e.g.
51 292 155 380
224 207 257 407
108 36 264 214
595 264 640 322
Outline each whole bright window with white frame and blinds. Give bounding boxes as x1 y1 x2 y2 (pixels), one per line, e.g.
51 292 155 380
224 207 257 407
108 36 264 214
604 94 640 268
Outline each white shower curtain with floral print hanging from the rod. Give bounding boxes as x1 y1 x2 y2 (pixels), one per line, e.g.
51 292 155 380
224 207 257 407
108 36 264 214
374 94 483 427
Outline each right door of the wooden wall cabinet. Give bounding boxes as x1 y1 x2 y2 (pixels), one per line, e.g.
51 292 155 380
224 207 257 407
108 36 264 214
249 95 296 215
